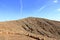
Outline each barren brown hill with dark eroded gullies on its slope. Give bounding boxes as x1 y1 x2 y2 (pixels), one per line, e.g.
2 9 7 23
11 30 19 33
0 17 60 40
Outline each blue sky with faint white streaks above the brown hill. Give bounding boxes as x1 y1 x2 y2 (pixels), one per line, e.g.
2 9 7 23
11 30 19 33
0 0 60 21
